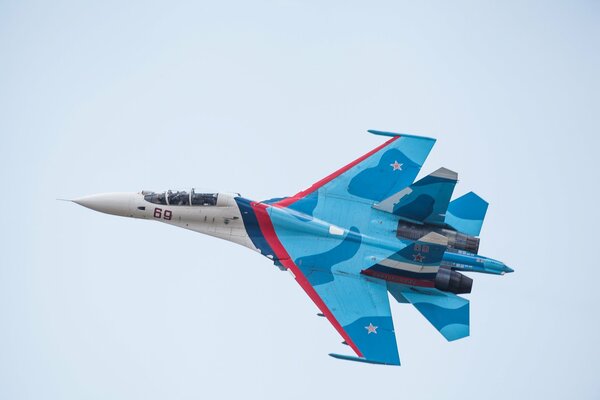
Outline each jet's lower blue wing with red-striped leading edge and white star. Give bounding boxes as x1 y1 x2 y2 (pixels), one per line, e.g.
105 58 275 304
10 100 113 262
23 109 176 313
242 203 400 365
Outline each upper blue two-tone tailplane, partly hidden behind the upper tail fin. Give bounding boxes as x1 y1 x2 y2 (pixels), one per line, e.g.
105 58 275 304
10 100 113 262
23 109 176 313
446 192 488 236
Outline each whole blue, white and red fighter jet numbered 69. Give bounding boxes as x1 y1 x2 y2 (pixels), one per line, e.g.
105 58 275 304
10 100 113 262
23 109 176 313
73 131 513 365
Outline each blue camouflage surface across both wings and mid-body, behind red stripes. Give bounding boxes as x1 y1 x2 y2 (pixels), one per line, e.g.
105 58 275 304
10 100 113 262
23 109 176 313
268 132 442 365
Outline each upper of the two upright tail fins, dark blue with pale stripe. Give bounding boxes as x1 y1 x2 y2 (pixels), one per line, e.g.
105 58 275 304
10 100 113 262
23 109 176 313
373 168 458 225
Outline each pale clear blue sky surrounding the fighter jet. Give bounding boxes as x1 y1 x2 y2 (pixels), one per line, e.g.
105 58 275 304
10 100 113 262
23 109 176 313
0 0 600 400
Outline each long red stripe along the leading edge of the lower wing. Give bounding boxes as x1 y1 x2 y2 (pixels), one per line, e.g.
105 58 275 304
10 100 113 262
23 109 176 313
251 202 363 357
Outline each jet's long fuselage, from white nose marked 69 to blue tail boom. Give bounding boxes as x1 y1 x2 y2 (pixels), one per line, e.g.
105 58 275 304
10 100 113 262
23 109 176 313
74 189 512 290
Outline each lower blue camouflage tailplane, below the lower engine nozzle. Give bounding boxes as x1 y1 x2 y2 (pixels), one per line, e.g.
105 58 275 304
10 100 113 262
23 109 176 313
392 286 469 341
